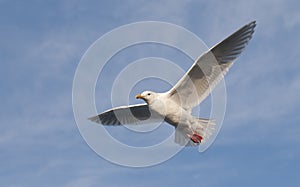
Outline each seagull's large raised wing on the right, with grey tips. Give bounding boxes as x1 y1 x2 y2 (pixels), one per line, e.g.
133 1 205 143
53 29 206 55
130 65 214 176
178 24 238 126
168 21 256 110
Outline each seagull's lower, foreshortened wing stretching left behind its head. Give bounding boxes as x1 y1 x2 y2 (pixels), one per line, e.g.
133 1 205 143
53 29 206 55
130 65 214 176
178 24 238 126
88 104 163 125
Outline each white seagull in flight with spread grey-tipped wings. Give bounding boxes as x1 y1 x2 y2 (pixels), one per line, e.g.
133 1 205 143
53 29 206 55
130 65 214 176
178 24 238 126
88 21 256 146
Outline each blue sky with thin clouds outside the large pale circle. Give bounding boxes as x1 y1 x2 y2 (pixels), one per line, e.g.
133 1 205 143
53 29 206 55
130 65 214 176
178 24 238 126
0 0 300 187
